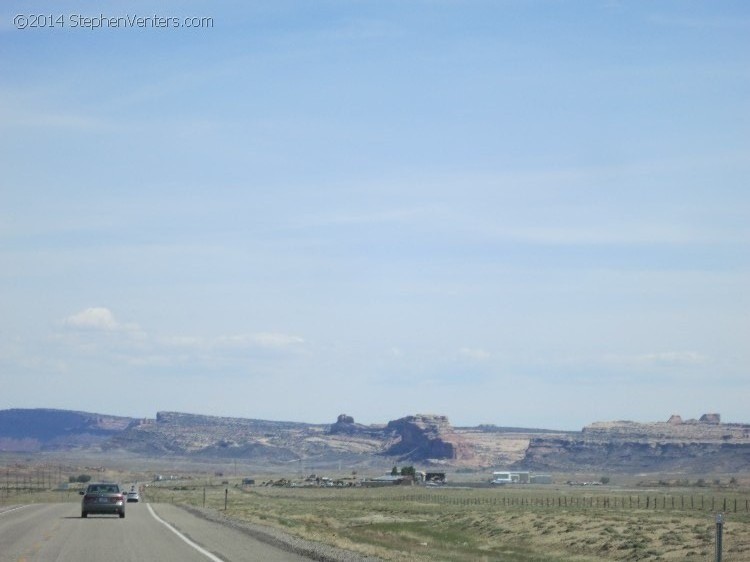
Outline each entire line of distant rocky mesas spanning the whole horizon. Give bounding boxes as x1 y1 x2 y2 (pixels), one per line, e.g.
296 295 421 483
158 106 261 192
0 409 750 473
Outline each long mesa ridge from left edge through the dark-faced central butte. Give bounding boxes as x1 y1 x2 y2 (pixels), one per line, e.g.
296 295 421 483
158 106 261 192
0 410 471 463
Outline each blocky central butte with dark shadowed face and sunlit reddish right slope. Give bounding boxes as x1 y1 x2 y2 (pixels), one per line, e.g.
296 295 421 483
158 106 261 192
385 414 472 460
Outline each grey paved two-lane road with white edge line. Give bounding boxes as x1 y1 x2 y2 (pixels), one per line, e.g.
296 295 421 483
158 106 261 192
0 503 309 562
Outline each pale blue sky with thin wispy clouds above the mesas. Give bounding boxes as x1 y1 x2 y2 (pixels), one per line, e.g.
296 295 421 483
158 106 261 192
0 0 750 430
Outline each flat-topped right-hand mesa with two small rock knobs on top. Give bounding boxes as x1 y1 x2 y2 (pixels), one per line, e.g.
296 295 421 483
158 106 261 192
519 414 750 472
